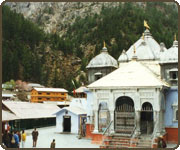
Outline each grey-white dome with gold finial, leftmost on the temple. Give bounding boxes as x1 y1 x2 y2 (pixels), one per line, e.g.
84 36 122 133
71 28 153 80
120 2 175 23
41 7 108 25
86 47 118 68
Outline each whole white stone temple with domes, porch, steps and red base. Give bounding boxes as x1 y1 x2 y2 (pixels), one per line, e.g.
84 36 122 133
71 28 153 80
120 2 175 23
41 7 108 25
86 21 178 148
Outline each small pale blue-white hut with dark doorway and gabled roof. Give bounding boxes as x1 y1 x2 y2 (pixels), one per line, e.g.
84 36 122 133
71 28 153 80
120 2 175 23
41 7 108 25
56 106 86 134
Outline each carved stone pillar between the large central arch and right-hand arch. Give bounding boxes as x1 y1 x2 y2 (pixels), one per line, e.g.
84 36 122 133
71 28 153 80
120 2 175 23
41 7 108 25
135 110 141 136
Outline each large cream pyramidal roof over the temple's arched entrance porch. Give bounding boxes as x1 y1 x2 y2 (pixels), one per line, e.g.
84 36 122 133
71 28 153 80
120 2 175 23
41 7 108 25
88 61 169 89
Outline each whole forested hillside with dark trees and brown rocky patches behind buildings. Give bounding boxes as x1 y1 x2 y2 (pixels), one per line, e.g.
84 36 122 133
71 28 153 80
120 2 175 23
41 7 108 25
2 2 178 91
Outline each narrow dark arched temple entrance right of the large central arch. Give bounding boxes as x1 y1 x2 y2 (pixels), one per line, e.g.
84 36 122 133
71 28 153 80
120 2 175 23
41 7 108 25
141 102 154 134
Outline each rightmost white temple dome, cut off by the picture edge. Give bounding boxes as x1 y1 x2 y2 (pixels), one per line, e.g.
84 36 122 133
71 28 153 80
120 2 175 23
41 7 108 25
160 40 178 63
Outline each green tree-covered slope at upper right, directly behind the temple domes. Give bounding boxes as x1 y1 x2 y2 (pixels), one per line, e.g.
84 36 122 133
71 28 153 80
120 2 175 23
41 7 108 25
64 2 178 61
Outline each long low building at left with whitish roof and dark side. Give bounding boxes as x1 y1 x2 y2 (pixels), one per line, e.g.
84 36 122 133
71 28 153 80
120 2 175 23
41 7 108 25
2 101 60 130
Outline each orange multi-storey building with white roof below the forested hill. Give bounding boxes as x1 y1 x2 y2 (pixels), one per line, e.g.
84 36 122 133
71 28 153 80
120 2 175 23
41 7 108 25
31 88 68 103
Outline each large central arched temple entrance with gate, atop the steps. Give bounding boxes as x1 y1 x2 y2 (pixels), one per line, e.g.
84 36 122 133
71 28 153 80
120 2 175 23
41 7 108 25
114 96 135 134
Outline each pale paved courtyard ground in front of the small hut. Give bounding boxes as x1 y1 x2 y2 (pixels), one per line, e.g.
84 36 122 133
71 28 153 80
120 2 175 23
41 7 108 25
20 126 99 148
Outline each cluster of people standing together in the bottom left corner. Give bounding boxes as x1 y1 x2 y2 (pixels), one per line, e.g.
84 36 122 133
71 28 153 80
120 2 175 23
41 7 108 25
2 130 26 148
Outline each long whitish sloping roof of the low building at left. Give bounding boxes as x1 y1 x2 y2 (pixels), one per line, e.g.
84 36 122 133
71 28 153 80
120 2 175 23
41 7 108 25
2 101 60 119
